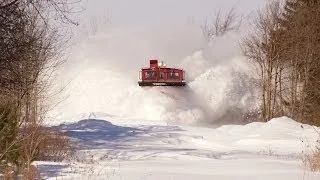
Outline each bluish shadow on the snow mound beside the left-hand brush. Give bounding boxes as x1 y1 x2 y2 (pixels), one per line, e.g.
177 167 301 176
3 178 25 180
52 119 188 150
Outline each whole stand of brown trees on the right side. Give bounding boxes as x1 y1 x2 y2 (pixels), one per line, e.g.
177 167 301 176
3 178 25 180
241 0 320 125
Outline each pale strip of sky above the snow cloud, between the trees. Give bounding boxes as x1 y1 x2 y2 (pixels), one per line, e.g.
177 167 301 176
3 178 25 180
80 0 267 24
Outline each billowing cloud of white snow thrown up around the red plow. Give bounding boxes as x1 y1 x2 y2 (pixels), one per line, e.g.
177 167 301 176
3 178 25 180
47 22 256 124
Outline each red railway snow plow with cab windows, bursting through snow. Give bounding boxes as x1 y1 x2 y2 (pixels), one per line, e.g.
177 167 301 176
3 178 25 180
138 60 186 86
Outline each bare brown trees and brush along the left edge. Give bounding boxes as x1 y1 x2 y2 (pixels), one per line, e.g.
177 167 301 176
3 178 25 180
0 0 78 179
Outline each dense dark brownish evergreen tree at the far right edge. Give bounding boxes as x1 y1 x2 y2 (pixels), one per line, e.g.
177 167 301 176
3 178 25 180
279 0 320 124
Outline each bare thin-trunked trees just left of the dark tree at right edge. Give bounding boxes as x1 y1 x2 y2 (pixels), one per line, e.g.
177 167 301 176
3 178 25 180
241 2 282 121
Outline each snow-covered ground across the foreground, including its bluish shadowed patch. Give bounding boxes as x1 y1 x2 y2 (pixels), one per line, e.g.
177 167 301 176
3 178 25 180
37 115 320 180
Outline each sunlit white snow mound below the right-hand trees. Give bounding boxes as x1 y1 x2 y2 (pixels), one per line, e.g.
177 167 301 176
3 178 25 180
211 116 320 156
